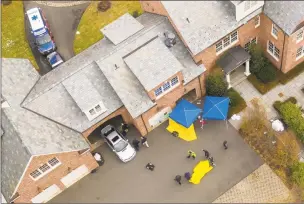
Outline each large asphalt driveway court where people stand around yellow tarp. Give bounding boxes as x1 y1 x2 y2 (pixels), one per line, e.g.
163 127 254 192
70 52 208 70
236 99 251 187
51 121 263 203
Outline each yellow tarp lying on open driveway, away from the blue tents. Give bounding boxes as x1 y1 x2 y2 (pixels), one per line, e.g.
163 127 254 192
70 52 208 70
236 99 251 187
189 160 213 184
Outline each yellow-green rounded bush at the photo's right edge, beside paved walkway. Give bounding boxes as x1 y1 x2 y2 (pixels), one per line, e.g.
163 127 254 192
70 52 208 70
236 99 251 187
279 102 304 142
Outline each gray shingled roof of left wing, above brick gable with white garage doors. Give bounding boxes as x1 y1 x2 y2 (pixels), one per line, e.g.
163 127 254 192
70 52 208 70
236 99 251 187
1 58 89 201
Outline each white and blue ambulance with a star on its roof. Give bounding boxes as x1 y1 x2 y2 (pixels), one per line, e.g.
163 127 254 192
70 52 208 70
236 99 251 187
26 8 56 55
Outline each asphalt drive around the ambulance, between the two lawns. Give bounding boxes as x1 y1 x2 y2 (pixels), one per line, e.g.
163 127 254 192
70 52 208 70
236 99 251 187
23 1 90 75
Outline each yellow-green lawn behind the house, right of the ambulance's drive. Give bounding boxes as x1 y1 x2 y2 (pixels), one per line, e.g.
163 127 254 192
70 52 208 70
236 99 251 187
74 1 143 54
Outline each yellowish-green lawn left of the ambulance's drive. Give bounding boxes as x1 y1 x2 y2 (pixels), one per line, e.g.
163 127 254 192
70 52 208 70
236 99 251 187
1 1 38 69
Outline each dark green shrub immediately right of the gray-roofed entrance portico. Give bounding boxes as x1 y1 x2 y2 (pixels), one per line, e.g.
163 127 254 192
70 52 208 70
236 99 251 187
249 45 267 74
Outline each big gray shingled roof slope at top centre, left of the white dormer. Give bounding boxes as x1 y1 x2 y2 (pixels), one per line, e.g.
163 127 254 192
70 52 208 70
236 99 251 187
162 1 262 55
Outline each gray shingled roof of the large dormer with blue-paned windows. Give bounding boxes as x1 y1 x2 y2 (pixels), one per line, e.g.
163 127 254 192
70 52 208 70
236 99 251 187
124 37 184 91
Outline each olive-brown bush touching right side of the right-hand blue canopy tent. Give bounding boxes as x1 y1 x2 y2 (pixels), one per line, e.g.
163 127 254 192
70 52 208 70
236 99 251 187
227 88 247 118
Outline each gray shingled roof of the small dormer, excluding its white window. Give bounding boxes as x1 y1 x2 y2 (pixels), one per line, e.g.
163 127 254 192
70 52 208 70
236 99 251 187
62 73 102 112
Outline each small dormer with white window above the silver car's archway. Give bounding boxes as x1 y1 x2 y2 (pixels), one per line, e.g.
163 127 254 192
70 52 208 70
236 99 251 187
62 74 107 121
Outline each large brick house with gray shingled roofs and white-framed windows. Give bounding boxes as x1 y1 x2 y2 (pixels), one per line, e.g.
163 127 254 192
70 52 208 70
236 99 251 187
1 1 304 203
